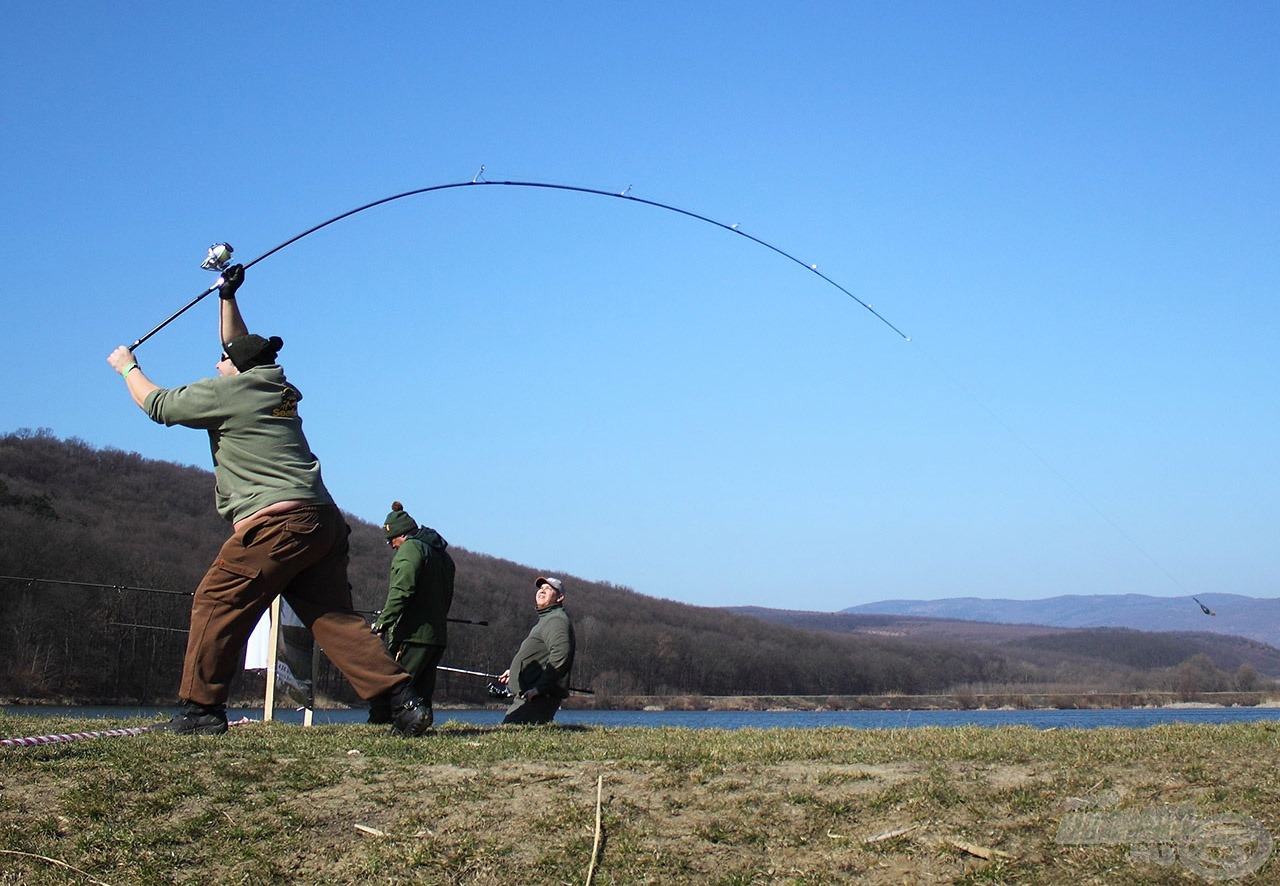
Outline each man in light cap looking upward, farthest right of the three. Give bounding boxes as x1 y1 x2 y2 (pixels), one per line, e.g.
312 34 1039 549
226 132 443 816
498 576 575 723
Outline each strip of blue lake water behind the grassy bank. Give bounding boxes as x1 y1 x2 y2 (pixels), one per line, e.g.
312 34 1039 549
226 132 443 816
0 705 1280 737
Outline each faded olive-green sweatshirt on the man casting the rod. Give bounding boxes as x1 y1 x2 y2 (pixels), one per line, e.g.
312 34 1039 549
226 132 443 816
142 364 333 522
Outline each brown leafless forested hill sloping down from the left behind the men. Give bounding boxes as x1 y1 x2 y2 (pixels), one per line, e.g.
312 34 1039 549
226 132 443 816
0 430 1275 703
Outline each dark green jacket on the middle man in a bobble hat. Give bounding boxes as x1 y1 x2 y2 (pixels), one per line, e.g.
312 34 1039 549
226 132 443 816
374 526 454 650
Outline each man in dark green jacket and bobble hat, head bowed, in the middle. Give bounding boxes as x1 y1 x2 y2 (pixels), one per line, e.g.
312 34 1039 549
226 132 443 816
369 502 454 723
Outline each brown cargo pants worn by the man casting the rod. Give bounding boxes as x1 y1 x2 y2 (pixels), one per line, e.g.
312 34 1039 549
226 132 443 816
179 504 410 704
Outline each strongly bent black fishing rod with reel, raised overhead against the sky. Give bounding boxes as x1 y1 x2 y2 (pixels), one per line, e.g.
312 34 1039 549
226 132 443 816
129 166 911 351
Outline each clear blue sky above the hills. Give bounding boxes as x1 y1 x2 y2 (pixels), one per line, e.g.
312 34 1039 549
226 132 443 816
0 0 1280 609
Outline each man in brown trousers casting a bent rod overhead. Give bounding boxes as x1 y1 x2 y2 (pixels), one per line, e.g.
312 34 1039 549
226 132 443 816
108 265 428 735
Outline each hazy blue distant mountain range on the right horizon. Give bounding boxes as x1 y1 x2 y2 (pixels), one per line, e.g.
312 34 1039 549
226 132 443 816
841 594 1280 647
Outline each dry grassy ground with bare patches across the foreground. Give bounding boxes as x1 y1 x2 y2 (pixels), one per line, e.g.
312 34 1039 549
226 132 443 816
0 712 1280 886
